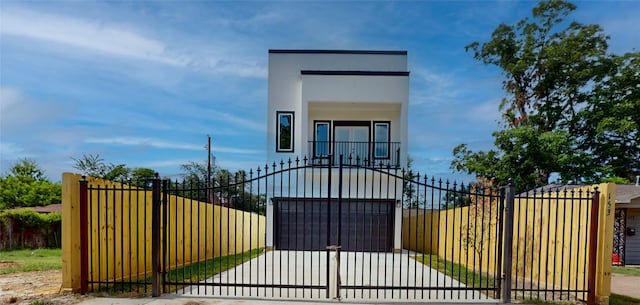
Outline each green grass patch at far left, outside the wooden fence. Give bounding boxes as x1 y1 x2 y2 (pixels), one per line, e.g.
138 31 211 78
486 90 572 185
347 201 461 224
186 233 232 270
0 249 62 274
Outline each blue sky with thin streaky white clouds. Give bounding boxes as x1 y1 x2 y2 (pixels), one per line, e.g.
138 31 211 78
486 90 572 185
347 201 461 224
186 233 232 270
0 0 640 181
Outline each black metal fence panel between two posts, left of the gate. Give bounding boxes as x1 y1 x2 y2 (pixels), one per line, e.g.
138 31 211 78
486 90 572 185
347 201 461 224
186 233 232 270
80 181 157 293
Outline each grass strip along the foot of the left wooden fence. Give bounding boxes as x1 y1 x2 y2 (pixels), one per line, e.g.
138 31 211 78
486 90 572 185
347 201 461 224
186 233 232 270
98 248 264 296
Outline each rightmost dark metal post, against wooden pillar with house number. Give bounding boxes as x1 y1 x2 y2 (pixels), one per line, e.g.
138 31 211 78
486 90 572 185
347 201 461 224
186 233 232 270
587 186 600 305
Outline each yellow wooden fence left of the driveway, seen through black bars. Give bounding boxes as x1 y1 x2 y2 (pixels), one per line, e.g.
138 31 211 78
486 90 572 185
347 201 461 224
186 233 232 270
62 173 266 291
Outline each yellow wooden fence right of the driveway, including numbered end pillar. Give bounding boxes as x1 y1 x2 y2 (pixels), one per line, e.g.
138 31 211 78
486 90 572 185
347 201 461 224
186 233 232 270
402 184 615 304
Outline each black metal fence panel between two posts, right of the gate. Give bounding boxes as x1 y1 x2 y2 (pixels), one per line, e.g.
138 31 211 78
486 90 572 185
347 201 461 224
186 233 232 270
512 187 597 301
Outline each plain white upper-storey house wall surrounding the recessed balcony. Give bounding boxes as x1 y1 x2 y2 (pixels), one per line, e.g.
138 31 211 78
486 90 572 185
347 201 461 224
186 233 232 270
267 53 409 164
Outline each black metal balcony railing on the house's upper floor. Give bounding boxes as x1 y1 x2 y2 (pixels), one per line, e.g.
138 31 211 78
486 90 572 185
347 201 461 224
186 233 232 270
308 141 400 168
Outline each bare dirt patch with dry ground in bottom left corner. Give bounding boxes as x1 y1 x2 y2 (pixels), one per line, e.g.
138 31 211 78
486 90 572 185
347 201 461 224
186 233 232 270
0 265 85 305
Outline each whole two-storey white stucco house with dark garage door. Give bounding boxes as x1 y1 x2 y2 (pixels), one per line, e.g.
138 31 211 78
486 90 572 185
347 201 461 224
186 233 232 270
267 50 409 251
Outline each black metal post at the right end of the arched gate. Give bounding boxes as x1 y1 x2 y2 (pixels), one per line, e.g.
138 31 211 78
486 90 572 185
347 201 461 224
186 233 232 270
502 179 515 303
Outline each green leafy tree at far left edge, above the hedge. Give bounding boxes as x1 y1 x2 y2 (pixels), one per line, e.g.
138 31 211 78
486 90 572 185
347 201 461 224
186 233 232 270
0 159 62 209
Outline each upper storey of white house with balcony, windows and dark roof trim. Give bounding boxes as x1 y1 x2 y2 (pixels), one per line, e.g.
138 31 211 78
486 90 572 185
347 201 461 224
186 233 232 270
267 50 409 166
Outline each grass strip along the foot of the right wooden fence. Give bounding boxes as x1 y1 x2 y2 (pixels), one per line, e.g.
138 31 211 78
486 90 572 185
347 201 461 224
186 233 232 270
414 254 494 289
